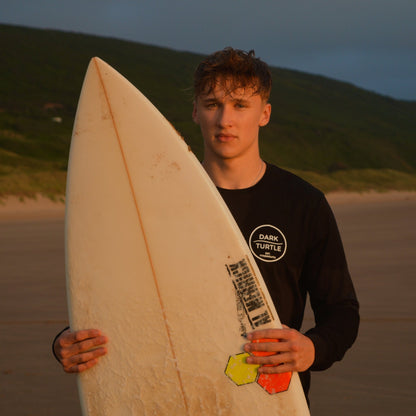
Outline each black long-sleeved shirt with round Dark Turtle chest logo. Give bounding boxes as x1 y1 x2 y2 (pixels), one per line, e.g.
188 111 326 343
219 164 359 395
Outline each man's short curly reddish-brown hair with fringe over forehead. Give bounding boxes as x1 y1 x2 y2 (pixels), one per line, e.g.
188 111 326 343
194 47 272 101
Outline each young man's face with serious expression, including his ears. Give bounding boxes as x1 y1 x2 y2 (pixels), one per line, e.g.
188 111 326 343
192 83 271 159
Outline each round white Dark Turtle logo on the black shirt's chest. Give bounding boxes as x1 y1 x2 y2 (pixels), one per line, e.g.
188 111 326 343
249 225 287 263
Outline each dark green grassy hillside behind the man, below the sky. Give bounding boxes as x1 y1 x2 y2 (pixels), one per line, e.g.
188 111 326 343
0 25 416 196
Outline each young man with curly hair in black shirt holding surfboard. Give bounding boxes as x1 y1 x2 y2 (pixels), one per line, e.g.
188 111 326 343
53 48 359 402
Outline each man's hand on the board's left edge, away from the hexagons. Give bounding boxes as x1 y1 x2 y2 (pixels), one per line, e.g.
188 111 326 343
53 329 108 373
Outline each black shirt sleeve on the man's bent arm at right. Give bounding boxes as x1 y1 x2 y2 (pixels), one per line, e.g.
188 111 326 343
302 196 360 371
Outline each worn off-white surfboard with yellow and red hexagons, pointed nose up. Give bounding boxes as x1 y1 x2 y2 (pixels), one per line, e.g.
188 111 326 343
65 58 309 416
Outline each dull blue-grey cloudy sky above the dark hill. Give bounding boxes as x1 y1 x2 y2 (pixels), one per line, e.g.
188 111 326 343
0 0 416 101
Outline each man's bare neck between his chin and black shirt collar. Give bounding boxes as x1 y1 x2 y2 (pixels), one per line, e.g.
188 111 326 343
202 156 266 189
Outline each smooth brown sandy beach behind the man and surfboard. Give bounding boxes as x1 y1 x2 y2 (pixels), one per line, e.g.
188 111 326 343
0 192 416 416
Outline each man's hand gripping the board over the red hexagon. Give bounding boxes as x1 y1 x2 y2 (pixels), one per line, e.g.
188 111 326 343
244 326 315 374
